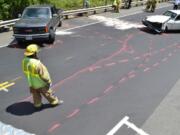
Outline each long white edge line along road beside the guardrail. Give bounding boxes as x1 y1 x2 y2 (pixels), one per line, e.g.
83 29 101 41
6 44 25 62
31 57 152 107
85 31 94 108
0 5 170 48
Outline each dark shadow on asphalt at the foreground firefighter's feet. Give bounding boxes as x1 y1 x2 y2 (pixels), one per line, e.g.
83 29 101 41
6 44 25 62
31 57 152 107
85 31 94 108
6 102 53 116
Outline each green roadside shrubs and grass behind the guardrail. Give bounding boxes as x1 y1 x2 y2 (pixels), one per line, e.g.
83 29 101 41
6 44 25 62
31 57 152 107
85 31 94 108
0 0 113 20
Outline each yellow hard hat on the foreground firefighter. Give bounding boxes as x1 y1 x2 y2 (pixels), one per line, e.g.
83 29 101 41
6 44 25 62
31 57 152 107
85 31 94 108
24 44 39 56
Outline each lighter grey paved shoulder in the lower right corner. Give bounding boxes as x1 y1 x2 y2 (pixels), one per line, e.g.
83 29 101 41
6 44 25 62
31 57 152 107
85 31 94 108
142 79 180 135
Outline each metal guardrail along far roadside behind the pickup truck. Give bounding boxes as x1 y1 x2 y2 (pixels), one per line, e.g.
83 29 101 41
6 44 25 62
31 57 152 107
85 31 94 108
0 0 168 28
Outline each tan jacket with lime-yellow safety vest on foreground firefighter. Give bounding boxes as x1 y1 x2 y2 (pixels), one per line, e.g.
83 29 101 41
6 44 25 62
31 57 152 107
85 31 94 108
22 57 51 89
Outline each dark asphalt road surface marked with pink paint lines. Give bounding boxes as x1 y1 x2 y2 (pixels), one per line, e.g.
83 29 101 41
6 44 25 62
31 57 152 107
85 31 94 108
0 3 180 135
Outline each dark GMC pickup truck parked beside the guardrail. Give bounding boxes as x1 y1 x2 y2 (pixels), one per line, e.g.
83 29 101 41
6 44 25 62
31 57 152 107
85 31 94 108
13 5 63 43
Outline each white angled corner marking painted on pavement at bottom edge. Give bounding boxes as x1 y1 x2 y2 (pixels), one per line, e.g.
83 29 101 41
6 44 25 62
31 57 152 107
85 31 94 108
106 116 149 135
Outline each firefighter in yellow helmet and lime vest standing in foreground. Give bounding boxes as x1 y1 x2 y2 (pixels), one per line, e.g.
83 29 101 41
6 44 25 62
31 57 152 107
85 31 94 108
22 44 63 109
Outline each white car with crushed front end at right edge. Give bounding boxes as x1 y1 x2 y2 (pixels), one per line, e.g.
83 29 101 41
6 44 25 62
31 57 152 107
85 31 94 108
142 10 180 33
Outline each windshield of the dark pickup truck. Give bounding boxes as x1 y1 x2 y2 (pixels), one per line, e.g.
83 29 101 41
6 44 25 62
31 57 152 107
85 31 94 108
22 8 50 19
